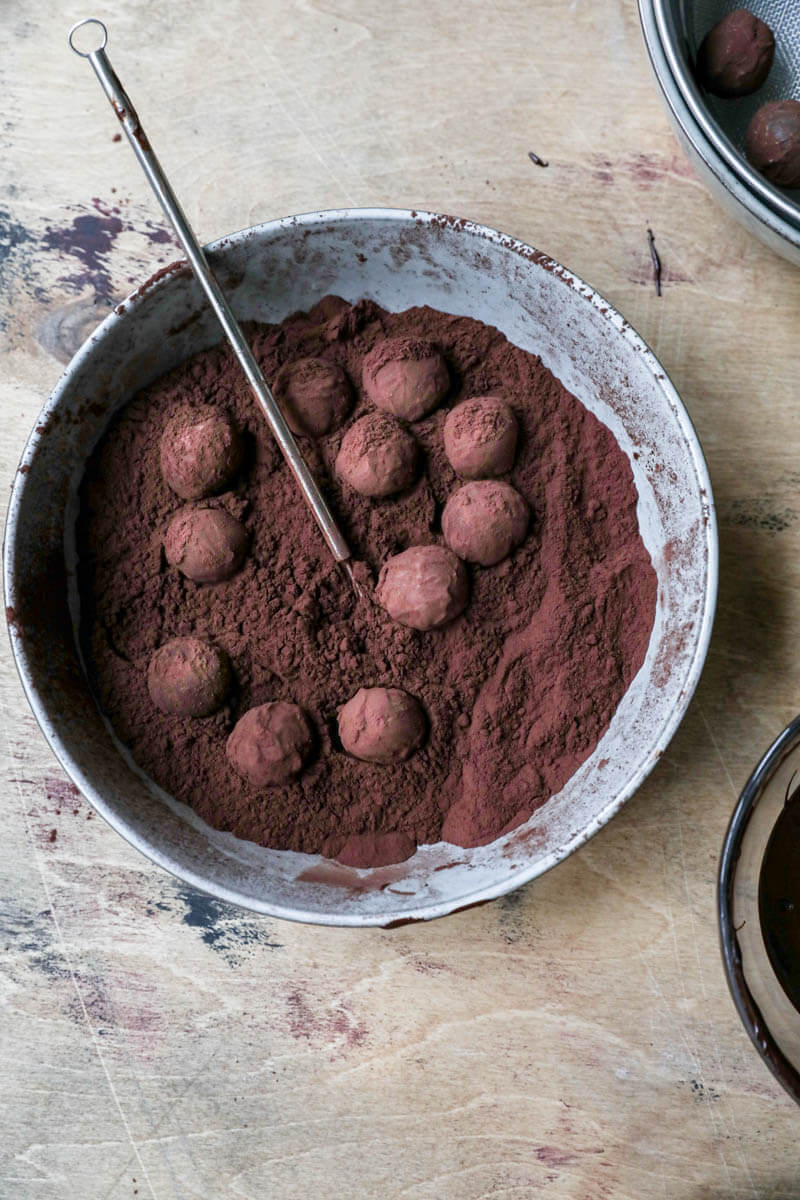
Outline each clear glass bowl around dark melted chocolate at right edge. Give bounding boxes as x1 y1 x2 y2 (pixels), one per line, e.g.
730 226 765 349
717 716 800 1104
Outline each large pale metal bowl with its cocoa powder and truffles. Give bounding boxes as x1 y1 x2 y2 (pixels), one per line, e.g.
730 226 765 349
5 210 717 925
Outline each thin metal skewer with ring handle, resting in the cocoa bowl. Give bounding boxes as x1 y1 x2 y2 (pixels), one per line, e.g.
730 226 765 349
70 17 361 595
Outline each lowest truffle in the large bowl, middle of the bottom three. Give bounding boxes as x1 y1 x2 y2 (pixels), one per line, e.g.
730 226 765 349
225 700 313 787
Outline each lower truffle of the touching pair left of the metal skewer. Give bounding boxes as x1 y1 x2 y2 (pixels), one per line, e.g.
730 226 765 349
164 508 247 583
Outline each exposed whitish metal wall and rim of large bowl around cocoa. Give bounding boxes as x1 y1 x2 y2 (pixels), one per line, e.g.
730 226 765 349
5 210 717 925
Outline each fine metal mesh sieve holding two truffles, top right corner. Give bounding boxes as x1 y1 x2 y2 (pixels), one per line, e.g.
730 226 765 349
652 0 800 226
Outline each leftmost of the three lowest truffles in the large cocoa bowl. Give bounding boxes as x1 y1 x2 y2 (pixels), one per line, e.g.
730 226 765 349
148 637 231 716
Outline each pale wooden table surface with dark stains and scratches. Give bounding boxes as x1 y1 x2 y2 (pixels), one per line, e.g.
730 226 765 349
0 0 800 1200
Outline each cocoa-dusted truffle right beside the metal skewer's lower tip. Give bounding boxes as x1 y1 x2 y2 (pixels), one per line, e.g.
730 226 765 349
375 546 469 630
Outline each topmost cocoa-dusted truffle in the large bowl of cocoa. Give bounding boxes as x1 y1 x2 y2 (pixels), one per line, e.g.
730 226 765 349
362 337 450 421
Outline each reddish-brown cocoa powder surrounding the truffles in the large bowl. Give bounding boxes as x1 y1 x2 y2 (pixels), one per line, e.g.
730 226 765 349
79 296 656 866
